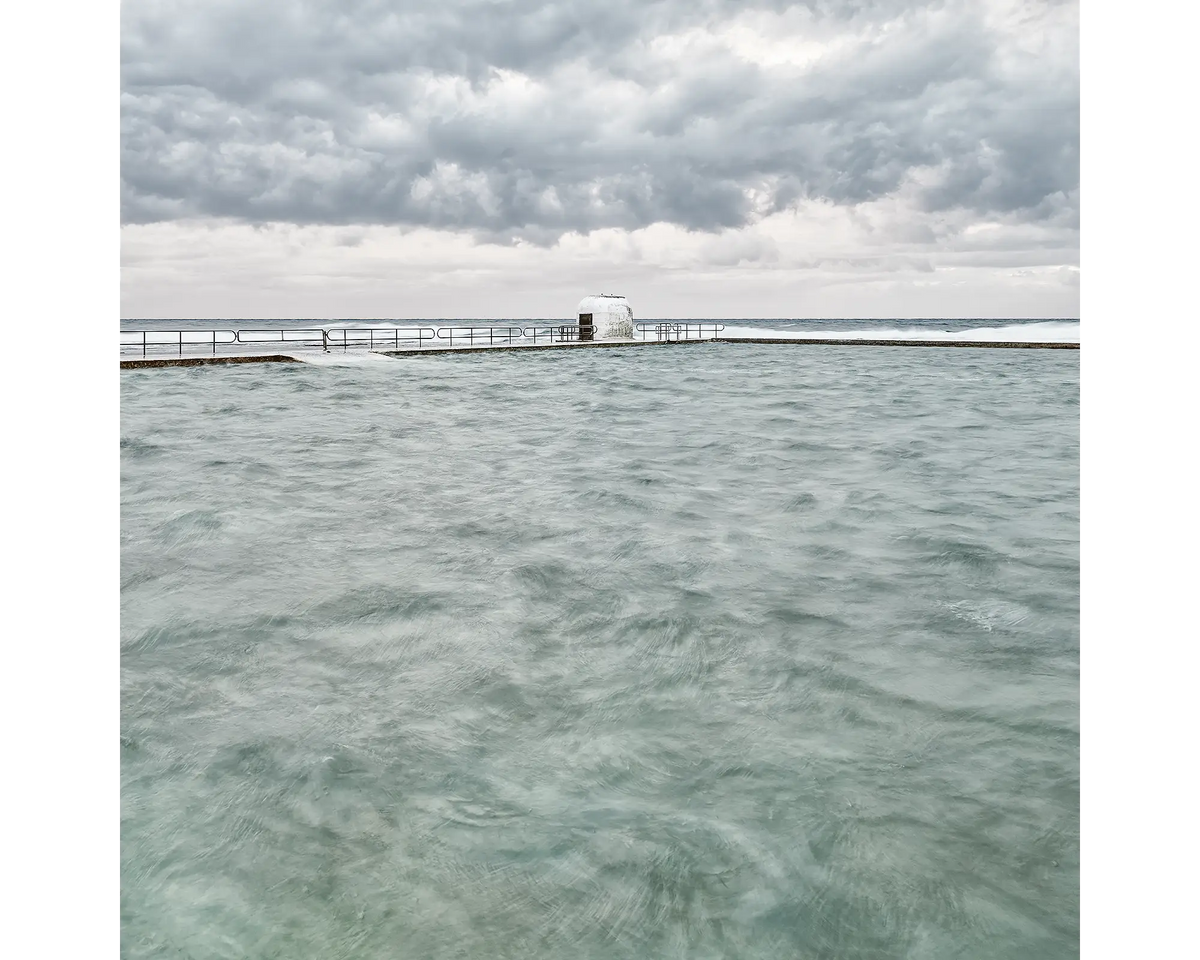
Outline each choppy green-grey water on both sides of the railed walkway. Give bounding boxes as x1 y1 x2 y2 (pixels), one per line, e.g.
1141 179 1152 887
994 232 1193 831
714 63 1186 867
116 320 1082 960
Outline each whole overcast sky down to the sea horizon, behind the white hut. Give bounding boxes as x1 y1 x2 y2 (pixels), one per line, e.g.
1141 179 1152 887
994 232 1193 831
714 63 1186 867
118 0 1084 318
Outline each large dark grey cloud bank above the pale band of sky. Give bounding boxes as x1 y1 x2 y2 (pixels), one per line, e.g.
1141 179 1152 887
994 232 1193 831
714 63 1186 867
118 0 1082 244
